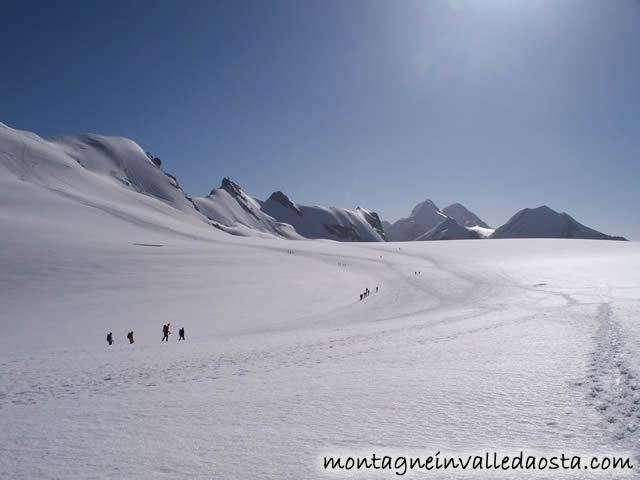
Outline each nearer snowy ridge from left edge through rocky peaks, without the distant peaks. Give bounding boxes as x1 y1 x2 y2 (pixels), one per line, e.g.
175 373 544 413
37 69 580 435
0 124 384 241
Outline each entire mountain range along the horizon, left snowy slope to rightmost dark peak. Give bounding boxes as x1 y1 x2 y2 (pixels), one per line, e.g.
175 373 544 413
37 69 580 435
0 123 625 242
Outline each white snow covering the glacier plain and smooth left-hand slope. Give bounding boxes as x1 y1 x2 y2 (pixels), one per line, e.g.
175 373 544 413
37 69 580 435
0 123 640 479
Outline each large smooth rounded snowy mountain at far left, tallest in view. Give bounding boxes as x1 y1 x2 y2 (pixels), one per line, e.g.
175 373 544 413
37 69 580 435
0 124 220 244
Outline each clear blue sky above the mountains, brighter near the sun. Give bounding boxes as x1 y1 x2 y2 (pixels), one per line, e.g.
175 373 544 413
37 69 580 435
0 0 640 240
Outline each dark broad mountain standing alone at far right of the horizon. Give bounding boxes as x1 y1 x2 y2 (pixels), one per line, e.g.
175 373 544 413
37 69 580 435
491 205 626 240
